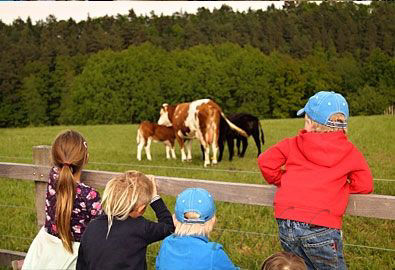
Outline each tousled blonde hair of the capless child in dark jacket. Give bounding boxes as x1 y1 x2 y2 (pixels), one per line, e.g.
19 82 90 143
102 171 154 238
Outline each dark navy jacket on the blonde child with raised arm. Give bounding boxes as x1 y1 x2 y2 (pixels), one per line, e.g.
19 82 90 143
77 199 174 270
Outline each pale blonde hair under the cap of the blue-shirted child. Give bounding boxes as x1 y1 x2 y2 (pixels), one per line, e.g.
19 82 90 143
173 212 217 237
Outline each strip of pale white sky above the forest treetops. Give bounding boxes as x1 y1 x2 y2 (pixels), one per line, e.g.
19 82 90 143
0 1 283 24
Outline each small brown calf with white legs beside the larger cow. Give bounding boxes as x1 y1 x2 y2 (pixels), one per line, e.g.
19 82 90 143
136 121 176 160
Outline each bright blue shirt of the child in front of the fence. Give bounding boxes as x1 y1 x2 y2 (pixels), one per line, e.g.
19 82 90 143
156 234 240 270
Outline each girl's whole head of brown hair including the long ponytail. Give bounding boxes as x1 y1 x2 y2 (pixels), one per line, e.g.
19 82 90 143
52 130 88 253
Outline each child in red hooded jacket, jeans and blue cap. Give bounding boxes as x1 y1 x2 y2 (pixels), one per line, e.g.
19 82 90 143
258 91 373 270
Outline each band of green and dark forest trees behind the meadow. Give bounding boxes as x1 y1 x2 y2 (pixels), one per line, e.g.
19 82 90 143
0 2 395 127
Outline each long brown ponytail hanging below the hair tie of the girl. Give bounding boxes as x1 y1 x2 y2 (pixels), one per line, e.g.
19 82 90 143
55 164 76 253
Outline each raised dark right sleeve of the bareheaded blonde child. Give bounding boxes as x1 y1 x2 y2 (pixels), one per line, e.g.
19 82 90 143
145 199 174 244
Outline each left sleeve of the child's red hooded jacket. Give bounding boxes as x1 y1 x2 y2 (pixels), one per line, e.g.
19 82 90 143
258 139 289 187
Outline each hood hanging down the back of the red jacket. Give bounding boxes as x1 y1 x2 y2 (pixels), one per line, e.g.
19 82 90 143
296 130 353 167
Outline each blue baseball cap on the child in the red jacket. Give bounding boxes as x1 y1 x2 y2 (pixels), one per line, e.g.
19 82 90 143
297 91 349 128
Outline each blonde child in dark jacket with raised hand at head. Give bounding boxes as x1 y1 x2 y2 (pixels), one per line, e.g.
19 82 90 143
77 171 174 270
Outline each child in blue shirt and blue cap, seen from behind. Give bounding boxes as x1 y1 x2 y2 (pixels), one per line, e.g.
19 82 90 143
156 188 240 270
